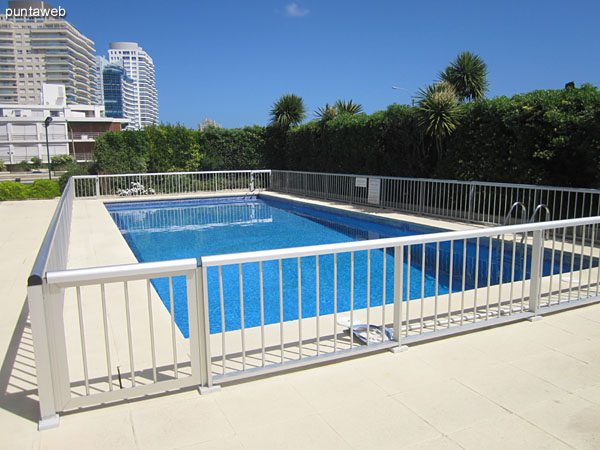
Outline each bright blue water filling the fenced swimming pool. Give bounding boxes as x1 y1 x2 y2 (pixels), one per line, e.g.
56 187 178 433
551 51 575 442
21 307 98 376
106 197 597 337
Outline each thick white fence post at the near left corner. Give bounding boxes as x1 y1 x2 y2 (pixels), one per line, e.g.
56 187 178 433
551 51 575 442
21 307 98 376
27 279 59 431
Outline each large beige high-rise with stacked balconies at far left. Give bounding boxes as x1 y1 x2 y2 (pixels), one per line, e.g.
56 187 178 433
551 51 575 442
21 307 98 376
0 1 97 105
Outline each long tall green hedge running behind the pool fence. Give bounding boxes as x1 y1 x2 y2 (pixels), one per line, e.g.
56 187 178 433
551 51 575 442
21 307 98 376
90 85 600 187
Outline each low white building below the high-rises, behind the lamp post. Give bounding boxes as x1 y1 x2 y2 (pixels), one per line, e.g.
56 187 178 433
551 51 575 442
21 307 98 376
0 85 127 164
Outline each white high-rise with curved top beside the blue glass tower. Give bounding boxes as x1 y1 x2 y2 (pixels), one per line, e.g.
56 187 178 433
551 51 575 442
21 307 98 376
105 42 158 129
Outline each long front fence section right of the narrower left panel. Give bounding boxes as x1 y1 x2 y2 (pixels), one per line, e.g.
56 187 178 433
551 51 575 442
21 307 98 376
200 217 600 382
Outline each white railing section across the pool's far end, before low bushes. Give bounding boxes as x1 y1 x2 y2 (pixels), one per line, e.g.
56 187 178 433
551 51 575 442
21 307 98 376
73 170 271 197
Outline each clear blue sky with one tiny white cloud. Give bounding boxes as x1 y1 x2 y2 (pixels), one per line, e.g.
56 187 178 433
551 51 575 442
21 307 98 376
49 0 600 128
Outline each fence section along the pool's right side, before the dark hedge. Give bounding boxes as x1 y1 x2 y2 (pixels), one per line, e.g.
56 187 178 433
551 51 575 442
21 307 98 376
270 170 600 225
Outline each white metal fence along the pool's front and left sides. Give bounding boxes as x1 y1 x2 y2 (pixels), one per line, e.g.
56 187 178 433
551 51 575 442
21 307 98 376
28 171 600 428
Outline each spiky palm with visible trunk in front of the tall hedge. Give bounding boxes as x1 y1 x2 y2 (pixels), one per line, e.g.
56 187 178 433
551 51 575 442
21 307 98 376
417 81 463 158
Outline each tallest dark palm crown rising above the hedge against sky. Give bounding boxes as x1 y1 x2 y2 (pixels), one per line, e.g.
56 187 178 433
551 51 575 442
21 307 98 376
440 52 489 102
